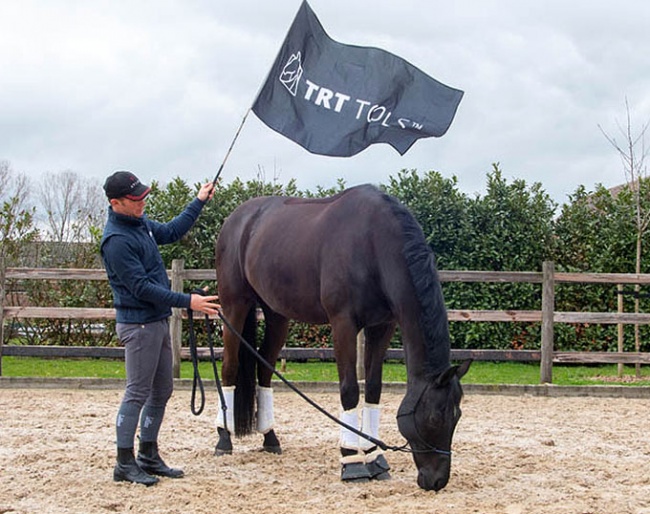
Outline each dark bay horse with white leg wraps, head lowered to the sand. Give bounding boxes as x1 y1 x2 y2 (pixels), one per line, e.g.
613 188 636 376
216 185 469 491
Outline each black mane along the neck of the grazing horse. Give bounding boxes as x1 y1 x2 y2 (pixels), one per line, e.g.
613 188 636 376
382 193 450 375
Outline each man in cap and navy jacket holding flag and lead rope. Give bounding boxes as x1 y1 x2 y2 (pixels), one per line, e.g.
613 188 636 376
100 171 219 486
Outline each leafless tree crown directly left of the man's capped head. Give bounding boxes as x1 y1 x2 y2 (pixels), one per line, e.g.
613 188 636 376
38 170 105 243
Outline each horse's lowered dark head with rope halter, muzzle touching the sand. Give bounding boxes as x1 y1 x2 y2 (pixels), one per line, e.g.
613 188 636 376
397 361 471 491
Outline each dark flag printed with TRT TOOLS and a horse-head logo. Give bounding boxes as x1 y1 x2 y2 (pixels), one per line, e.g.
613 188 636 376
253 1 463 157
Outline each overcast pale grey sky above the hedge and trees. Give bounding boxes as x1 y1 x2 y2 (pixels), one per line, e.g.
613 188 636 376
0 0 650 203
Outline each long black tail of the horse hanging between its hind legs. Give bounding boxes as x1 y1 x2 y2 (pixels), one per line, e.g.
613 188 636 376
234 305 257 436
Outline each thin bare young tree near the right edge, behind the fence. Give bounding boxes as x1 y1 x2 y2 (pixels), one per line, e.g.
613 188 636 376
598 98 650 377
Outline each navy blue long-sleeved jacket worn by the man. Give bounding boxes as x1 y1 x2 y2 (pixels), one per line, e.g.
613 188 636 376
100 198 204 323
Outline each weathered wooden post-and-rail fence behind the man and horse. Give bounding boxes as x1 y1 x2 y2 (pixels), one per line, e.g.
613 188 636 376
0 260 650 383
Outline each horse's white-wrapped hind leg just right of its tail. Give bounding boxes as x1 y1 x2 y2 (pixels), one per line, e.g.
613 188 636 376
256 308 289 454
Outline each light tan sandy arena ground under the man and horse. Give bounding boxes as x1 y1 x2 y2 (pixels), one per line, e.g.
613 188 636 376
0 389 650 514
